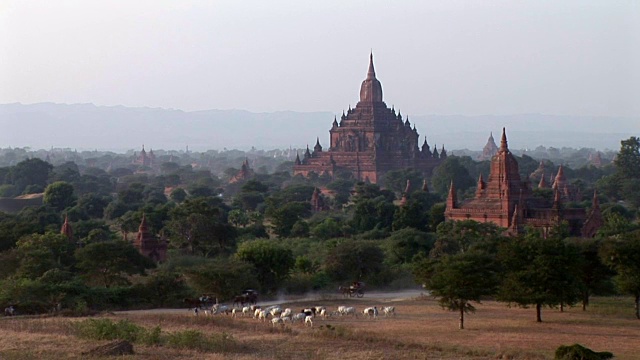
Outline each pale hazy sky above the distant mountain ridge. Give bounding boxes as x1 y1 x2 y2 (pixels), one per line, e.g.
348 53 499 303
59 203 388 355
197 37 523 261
0 0 640 116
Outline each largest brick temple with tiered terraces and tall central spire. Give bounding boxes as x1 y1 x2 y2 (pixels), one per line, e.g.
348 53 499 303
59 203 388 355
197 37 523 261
293 55 447 183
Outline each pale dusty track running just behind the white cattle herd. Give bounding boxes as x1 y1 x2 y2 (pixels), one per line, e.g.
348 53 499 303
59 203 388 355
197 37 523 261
115 289 428 314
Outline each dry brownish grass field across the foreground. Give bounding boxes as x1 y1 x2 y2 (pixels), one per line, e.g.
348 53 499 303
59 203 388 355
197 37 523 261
0 297 640 360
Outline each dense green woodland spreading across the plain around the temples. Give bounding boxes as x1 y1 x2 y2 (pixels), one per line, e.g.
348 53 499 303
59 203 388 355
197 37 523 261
0 137 640 320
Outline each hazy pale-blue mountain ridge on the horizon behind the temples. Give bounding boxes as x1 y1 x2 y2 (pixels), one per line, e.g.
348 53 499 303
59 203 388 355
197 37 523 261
0 103 640 152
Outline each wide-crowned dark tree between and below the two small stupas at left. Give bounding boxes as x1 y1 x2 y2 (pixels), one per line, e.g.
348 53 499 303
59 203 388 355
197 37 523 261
75 241 154 288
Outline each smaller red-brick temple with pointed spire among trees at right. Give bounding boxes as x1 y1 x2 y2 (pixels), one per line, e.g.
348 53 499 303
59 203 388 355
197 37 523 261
445 129 602 237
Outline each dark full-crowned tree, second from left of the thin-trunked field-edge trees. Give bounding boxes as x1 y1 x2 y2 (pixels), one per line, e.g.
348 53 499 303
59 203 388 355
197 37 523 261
497 232 581 322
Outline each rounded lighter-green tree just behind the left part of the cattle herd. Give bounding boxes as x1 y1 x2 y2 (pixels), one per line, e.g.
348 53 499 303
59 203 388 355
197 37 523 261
236 240 295 292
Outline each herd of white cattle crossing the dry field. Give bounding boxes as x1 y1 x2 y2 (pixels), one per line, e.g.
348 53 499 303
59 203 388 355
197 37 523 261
193 304 396 327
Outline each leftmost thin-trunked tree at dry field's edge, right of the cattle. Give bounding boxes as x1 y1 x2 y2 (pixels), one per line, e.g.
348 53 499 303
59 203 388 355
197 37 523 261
415 252 498 330
